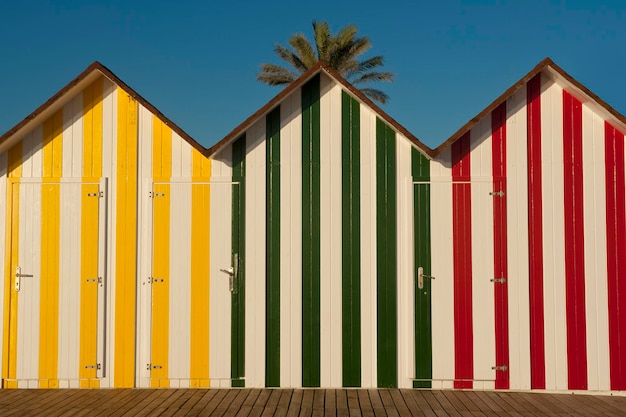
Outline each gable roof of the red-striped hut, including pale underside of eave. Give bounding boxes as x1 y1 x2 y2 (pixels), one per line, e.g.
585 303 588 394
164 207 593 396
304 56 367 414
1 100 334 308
433 58 626 156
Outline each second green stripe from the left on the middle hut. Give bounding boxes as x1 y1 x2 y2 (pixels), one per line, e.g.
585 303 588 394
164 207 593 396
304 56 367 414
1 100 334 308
265 107 280 387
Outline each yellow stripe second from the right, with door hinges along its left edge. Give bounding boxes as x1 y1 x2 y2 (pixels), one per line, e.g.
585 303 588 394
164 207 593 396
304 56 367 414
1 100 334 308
150 116 172 388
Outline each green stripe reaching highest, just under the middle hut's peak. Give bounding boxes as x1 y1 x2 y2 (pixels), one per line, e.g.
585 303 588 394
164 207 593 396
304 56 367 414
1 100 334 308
302 75 320 387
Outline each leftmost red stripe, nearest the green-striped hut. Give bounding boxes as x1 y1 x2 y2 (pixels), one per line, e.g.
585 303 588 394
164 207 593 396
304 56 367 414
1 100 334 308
452 132 474 388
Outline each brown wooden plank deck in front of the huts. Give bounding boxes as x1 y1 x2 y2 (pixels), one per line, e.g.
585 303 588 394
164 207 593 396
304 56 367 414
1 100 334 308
0 389 626 417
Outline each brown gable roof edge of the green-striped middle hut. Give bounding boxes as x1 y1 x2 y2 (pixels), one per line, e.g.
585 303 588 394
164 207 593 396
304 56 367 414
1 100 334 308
206 61 434 157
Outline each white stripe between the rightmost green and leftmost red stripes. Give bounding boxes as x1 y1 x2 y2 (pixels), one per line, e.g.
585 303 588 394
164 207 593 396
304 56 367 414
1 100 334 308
430 147 455 388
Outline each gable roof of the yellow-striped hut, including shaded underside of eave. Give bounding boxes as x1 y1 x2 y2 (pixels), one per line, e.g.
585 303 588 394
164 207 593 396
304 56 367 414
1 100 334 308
0 61 206 157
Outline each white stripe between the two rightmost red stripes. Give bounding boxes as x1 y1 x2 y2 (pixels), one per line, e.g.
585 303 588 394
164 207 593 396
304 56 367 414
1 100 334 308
582 106 611 391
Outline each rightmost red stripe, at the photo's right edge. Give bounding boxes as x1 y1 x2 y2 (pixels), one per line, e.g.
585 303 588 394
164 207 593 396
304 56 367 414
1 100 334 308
604 122 626 390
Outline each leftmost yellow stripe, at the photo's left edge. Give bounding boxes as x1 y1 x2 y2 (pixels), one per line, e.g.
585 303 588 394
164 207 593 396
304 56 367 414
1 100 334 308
2 142 22 388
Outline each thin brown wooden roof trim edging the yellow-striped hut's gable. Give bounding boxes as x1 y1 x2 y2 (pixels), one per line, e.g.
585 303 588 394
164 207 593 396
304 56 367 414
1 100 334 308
0 61 206 158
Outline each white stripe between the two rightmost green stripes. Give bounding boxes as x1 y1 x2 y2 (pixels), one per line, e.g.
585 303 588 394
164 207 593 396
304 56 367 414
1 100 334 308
396 134 415 388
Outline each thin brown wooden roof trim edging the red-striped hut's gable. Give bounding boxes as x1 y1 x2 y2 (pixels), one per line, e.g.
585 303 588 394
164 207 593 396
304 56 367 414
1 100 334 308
433 58 626 156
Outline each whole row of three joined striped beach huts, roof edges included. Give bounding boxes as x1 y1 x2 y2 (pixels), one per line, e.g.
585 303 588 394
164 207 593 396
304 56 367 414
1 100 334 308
0 59 626 391
